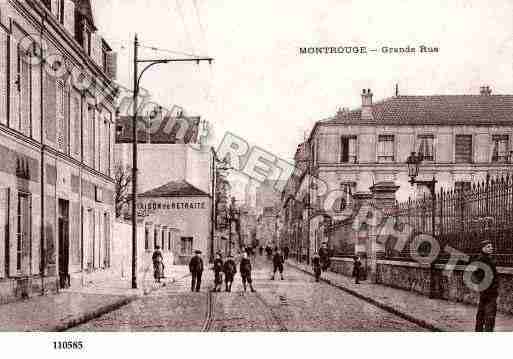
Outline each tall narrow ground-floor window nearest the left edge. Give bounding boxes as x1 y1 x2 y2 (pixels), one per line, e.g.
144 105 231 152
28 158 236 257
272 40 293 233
16 192 30 274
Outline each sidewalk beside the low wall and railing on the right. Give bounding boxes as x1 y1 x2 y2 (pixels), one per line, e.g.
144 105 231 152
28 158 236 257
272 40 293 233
287 260 513 331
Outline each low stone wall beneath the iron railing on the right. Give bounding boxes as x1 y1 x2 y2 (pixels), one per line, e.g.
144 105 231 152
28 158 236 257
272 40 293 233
376 260 513 314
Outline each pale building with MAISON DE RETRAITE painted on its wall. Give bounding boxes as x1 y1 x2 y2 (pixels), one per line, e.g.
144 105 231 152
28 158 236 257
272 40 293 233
115 115 215 264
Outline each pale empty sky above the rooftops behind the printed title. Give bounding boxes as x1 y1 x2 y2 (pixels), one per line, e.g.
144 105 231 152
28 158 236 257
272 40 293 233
92 0 513 161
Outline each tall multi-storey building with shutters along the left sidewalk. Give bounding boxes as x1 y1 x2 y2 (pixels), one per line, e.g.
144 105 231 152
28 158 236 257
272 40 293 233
0 0 116 301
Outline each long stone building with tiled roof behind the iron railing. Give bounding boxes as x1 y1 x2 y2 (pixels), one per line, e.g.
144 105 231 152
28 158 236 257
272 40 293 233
284 86 513 262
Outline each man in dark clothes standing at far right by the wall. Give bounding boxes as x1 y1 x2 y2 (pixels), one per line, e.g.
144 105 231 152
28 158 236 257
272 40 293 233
474 240 499 332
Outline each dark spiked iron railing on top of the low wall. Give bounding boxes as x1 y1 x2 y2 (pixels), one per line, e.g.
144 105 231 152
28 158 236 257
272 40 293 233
385 174 513 266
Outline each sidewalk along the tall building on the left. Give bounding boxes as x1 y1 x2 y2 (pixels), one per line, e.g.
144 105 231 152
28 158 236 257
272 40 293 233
0 266 188 332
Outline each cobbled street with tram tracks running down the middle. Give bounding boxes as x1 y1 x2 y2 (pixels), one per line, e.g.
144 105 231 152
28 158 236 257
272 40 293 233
71 258 424 331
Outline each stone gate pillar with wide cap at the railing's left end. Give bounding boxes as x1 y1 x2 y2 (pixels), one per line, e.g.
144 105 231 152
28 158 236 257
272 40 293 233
368 181 399 283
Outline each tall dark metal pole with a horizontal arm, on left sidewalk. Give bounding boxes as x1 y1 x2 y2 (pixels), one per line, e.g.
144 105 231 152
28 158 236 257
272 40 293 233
132 34 214 289
